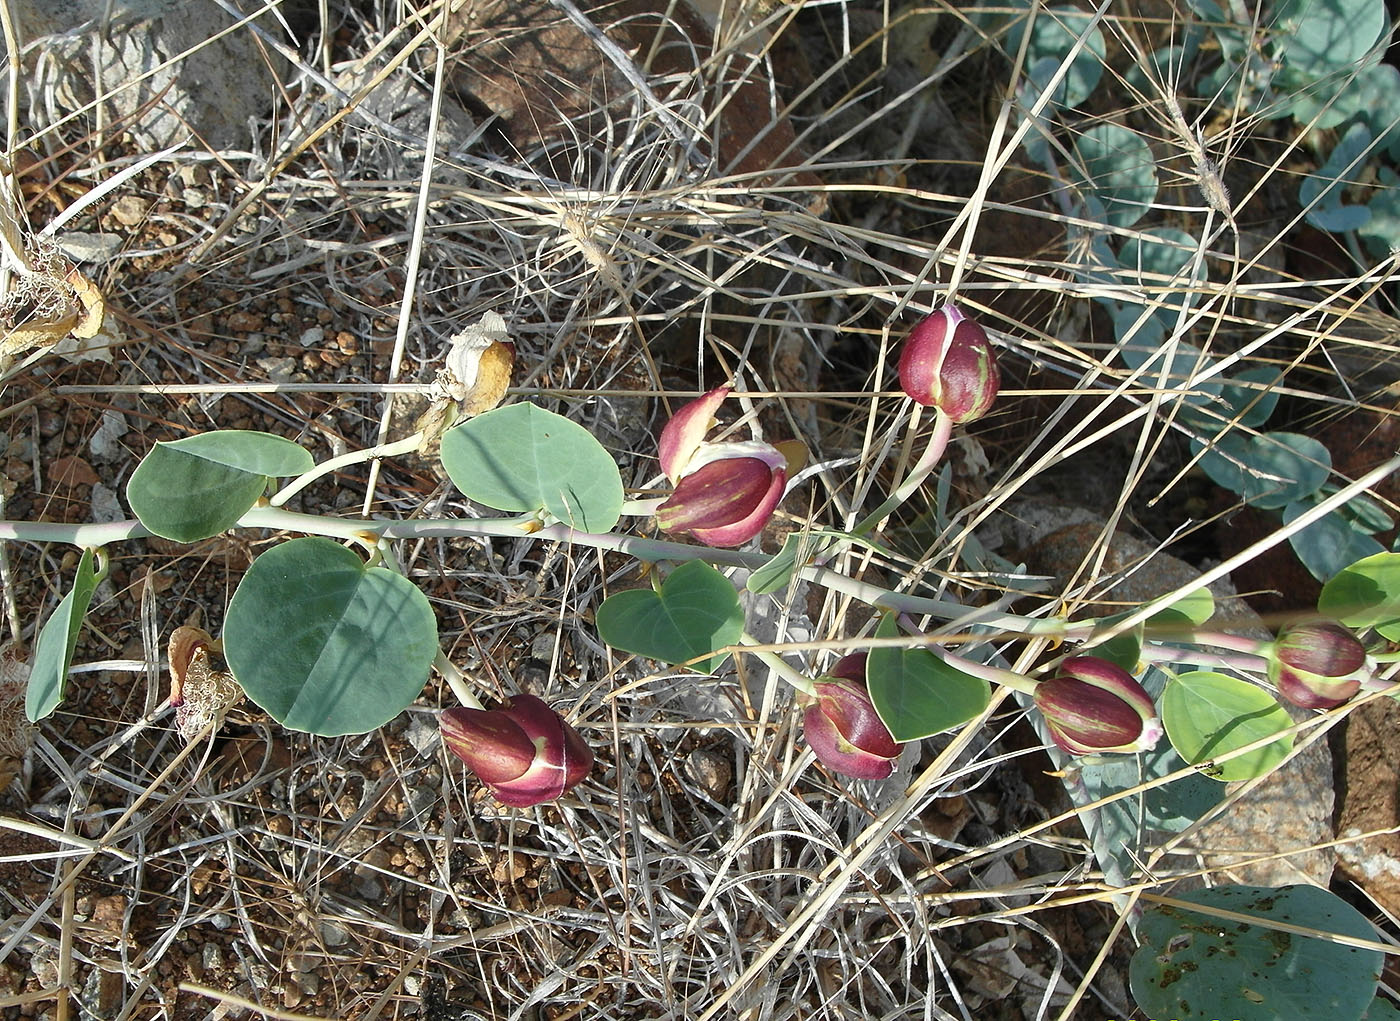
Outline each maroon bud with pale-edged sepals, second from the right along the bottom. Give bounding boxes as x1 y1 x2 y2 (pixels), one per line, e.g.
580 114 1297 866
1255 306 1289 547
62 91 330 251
1032 655 1162 755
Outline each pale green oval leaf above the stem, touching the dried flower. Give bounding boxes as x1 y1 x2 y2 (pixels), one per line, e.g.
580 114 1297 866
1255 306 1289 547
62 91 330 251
442 403 622 532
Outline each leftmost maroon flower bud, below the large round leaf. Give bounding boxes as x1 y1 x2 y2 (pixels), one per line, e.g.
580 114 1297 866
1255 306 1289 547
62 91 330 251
438 695 594 808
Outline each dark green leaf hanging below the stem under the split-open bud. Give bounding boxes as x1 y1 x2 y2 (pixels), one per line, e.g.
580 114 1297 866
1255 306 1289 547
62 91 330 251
596 560 743 674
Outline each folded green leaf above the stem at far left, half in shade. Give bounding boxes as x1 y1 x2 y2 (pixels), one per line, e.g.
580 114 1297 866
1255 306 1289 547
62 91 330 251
126 430 314 542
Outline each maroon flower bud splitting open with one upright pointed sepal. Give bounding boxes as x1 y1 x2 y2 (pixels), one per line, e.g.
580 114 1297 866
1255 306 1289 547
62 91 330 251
657 387 790 546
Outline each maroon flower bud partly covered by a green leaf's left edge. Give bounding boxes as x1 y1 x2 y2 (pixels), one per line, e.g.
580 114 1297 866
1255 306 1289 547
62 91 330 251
802 653 904 780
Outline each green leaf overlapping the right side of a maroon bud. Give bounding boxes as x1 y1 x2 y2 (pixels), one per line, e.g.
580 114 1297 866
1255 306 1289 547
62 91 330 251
865 615 991 741
